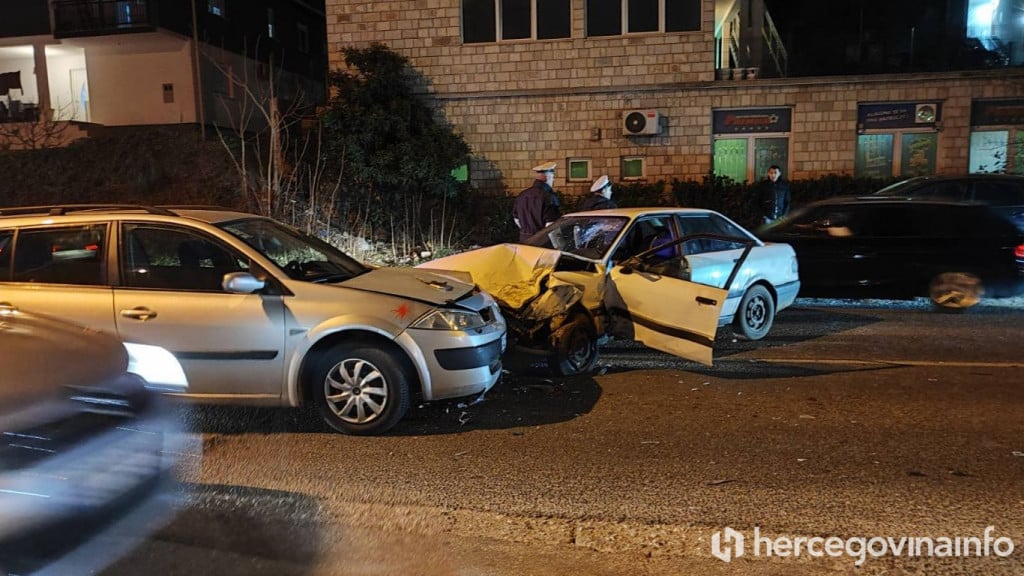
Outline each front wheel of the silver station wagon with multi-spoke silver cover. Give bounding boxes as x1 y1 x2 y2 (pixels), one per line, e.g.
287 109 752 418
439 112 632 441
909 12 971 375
311 342 410 436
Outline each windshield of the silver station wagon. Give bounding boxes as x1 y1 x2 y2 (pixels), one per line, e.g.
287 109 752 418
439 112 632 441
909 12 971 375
221 218 370 282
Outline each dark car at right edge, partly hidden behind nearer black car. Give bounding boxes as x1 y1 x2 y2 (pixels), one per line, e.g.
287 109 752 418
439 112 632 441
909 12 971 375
872 174 1024 230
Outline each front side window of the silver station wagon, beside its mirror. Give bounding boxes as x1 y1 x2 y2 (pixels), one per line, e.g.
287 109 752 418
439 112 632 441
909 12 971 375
120 223 249 292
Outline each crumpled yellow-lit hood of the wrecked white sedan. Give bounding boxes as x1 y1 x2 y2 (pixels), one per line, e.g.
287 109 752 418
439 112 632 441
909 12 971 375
417 244 562 310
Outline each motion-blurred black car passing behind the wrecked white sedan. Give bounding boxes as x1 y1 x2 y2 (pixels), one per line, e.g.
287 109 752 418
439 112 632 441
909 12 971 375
759 197 1024 308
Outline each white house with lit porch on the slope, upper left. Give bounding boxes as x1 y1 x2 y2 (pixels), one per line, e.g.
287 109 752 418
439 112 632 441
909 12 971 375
0 0 327 142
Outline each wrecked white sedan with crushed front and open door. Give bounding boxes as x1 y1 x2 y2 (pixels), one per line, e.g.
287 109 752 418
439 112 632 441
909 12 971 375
422 208 800 374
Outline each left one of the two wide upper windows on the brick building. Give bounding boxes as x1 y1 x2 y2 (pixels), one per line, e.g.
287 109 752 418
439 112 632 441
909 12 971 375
462 0 572 44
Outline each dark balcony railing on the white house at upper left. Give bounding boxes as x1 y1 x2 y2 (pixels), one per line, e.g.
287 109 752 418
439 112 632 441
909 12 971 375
53 0 155 38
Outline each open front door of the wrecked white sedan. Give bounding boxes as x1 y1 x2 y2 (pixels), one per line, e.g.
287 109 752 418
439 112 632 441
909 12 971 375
605 235 753 366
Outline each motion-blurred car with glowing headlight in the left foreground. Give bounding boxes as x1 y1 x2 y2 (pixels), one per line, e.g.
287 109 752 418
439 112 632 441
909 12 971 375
0 303 189 575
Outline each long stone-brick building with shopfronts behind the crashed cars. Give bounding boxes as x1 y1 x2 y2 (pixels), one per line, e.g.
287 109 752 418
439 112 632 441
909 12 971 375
326 0 1024 194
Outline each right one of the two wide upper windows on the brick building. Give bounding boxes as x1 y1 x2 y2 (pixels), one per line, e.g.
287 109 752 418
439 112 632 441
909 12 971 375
585 0 701 37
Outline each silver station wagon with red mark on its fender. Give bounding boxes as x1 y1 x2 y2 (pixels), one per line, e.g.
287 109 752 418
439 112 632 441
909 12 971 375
0 205 505 435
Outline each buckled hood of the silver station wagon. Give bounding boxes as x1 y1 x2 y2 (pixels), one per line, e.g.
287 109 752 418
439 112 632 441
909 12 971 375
341 268 474 304
